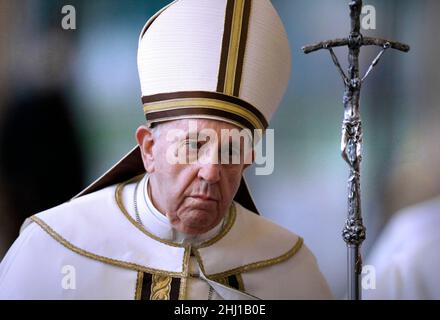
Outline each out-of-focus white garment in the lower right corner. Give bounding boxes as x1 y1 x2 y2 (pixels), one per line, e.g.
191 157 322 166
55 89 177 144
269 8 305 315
363 197 440 300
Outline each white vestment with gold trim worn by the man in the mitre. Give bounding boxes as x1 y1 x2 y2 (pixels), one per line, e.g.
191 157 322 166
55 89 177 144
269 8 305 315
0 177 332 300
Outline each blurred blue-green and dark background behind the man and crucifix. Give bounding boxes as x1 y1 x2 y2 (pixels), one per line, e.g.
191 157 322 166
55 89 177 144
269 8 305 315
0 0 440 298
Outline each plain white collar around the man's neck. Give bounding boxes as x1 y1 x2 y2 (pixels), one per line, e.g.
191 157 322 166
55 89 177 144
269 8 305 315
135 174 225 244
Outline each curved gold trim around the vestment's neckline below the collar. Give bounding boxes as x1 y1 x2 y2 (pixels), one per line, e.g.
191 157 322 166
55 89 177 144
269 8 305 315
115 176 237 248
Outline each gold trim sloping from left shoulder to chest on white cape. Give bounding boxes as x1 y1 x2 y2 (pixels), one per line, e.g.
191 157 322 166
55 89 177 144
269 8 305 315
31 216 183 278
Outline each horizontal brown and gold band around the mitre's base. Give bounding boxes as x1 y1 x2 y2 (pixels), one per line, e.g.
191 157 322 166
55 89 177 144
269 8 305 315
142 91 268 130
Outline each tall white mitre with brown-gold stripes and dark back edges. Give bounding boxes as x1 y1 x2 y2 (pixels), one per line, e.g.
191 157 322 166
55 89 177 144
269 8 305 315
78 0 291 212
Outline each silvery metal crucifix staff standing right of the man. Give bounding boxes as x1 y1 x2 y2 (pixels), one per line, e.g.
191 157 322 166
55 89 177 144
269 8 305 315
302 0 410 300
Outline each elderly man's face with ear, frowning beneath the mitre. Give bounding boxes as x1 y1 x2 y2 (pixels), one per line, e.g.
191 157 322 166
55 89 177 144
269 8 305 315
136 119 252 235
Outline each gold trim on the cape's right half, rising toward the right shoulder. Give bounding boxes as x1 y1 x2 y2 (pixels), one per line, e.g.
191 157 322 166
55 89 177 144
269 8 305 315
193 237 304 281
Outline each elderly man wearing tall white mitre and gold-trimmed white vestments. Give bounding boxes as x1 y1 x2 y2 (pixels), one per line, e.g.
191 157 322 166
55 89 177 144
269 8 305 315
0 0 331 300
